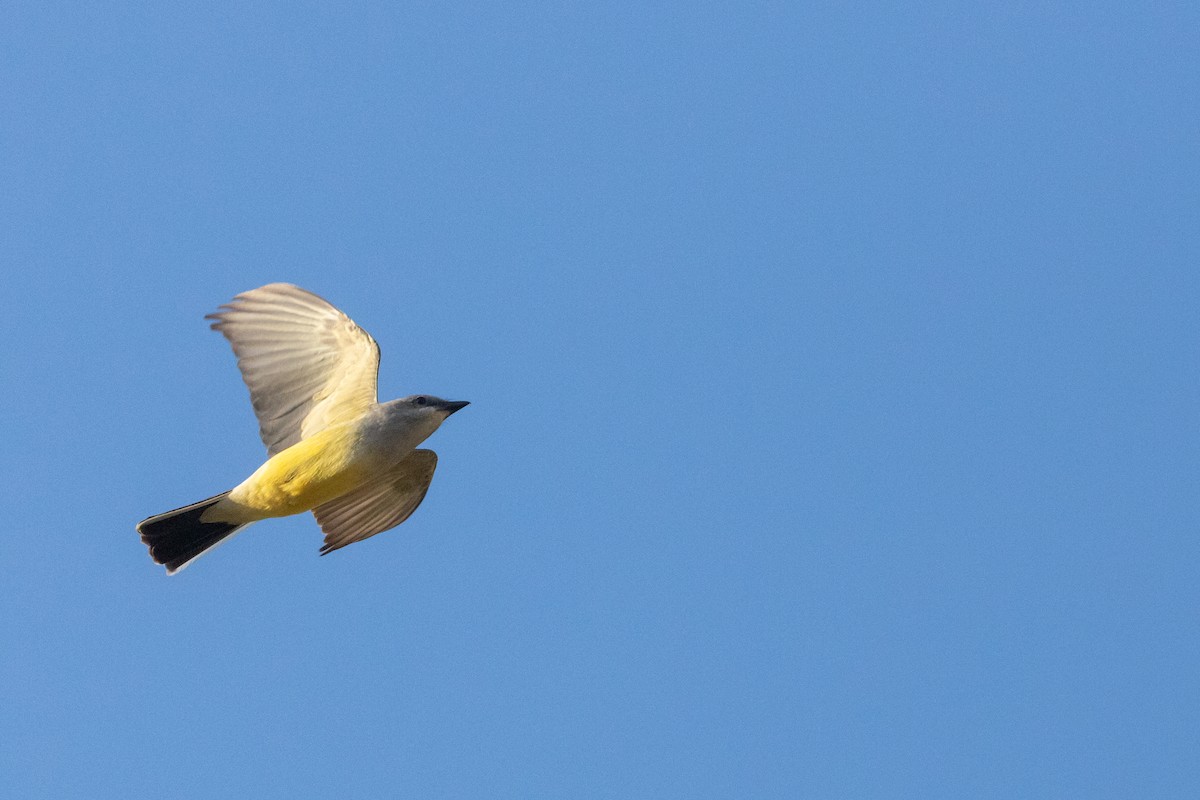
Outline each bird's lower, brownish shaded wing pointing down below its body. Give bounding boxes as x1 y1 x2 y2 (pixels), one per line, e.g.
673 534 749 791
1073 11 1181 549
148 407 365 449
312 450 438 555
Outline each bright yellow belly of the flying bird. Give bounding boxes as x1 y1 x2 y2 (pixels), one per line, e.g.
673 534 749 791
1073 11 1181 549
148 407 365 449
229 425 370 518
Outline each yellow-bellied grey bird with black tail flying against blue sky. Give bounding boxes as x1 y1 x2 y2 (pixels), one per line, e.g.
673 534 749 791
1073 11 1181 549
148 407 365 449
137 283 468 575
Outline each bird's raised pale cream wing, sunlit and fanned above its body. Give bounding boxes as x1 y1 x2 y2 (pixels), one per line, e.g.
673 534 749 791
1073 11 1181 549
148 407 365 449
205 283 379 456
